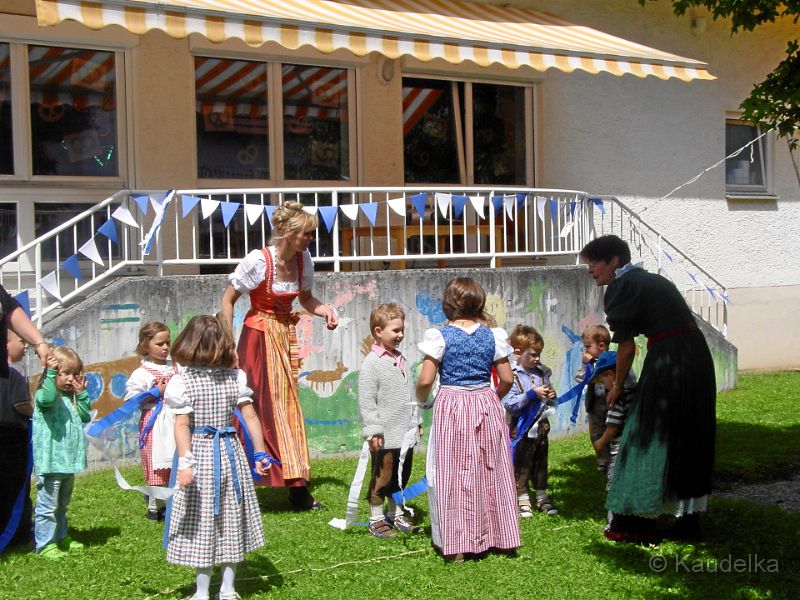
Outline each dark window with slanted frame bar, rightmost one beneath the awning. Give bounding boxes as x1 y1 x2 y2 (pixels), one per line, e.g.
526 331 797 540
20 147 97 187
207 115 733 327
403 77 533 185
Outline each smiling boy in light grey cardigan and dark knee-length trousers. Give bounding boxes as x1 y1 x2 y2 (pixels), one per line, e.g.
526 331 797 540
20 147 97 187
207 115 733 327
358 304 422 538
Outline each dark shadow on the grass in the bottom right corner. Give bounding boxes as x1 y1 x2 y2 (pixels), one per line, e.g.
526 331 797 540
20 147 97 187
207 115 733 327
587 498 800 600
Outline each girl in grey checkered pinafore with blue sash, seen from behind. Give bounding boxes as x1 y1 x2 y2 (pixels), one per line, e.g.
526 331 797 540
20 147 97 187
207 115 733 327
164 316 269 600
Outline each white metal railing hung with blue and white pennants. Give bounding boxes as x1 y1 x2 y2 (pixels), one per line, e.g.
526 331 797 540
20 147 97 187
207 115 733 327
0 186 727 333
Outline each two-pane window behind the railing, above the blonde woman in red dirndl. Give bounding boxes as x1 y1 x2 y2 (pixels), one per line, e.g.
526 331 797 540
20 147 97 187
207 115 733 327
195 56 353 183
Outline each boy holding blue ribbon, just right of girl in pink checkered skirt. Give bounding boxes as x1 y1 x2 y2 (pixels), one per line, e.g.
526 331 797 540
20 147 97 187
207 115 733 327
503 325 558 517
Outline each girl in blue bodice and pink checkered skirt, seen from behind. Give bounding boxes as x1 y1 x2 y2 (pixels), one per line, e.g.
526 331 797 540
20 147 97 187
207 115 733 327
417 277 520 562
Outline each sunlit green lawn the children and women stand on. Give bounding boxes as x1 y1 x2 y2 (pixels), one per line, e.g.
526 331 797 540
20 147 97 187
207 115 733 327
0 373 800 600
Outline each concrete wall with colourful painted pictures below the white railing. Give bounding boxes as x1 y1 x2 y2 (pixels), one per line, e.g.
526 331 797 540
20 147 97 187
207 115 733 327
39 267 736 458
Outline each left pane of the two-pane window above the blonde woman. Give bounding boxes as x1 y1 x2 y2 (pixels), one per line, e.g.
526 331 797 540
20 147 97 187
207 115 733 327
194 56 269 179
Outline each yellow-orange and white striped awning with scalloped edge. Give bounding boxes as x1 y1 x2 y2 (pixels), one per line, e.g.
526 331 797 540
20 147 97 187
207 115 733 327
36 0 714 81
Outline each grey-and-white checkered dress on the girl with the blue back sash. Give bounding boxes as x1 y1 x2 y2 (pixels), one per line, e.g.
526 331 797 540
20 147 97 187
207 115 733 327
167 368 264 568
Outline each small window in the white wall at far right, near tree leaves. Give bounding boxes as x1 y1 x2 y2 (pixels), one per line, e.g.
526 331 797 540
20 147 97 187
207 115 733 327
725 119 769 195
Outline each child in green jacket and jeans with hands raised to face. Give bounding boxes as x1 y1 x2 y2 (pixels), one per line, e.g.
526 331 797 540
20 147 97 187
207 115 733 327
33 346 91 558
